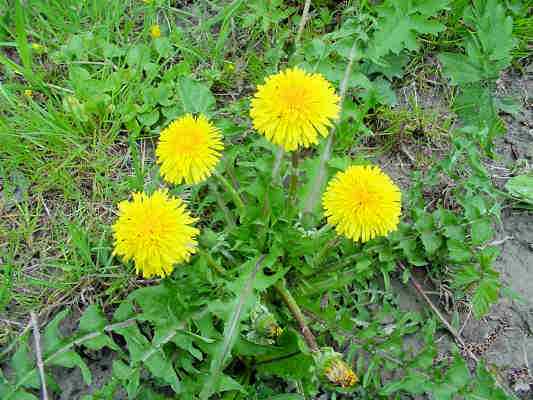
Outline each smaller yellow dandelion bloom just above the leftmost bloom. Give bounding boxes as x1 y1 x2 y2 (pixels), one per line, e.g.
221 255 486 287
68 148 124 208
155 114 224 184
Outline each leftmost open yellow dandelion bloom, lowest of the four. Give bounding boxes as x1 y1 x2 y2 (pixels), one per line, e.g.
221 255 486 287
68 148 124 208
113 190 199 278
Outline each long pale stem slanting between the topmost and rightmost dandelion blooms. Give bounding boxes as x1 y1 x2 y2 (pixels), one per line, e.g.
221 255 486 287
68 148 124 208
304 40 357 214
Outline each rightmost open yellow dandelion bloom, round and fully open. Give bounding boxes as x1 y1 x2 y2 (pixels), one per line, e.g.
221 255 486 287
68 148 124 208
322 165 401 242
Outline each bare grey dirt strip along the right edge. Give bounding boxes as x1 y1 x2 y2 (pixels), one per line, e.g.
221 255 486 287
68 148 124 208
462 65 533 398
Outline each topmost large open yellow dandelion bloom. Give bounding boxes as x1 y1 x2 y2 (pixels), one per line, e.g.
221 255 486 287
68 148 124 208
250 68 340 151
